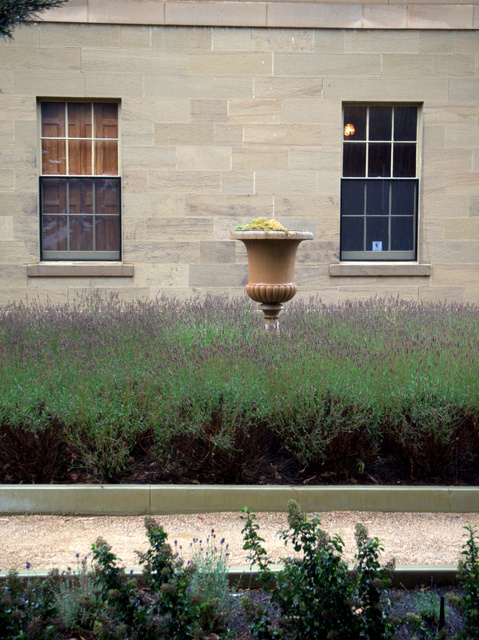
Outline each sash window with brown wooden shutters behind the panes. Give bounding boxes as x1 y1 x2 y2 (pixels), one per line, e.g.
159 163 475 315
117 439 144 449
40 101 120 260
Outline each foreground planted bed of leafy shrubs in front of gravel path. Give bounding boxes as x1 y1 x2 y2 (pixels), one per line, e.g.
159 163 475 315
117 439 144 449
0 510 479 640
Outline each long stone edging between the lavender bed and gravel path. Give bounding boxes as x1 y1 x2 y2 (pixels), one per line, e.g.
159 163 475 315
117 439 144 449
0 484 479 516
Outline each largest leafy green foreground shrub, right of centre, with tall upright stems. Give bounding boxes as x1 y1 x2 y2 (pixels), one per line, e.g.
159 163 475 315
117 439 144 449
243 501 394 640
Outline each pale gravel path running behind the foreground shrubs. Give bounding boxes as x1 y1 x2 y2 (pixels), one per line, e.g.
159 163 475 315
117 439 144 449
0 511 479 571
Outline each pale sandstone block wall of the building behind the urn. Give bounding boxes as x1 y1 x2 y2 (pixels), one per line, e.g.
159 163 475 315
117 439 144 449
0 0 479 304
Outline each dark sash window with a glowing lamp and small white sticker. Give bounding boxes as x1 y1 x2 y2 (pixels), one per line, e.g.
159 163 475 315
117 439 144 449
341 105 419 261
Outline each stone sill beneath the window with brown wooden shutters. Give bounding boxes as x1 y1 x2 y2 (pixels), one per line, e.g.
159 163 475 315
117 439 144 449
27 262 134 278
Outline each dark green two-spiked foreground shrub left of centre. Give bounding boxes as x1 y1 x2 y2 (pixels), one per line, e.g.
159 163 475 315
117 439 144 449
93 518 231 640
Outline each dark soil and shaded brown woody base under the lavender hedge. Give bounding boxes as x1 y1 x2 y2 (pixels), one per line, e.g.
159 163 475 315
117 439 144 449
0 424 479 486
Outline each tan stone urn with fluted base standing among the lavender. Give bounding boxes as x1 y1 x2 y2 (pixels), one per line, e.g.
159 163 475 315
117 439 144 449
231 230 313 329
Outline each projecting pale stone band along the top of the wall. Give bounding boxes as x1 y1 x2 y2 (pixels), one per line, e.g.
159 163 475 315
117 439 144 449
38 0 479 29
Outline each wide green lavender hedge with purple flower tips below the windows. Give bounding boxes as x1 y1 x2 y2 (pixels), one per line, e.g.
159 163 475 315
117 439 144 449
0 297 479 480
